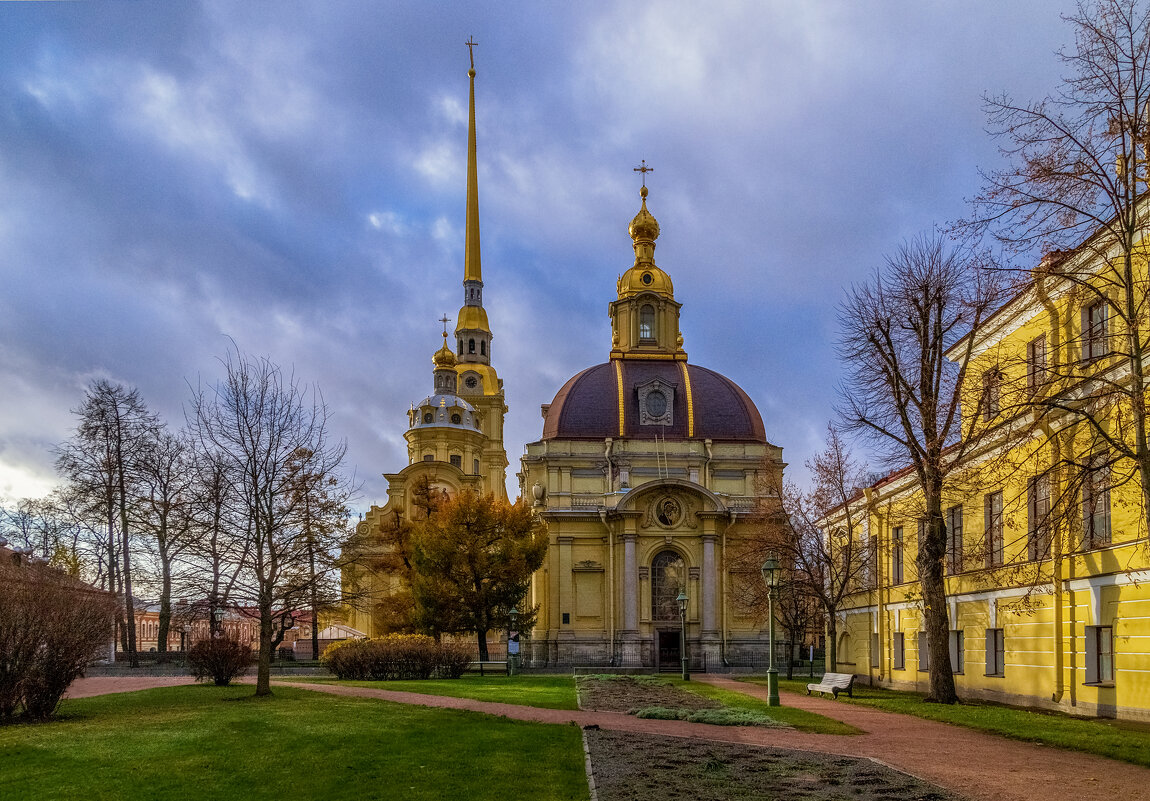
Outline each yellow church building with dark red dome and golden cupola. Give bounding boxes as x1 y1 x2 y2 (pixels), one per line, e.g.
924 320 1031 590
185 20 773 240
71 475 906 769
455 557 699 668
519 186 783 670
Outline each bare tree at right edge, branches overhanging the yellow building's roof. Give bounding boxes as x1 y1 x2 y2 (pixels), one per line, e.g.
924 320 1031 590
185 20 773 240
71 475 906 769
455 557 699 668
967 0 1150 544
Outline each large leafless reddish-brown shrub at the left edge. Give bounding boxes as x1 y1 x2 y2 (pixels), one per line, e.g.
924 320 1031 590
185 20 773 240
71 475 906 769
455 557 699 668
0 563 115 721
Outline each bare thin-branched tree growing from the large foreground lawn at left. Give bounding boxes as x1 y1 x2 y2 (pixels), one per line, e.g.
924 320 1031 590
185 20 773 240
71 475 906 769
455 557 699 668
191 352 346 695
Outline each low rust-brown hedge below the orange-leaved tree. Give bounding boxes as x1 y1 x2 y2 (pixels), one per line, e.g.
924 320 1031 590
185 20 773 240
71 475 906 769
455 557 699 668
320 634 472 681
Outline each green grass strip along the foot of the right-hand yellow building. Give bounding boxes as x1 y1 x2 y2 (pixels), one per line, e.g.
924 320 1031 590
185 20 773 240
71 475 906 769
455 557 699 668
746 677 1150 768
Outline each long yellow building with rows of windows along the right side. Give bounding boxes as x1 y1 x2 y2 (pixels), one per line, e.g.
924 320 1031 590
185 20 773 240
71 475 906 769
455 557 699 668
827 242 1150 718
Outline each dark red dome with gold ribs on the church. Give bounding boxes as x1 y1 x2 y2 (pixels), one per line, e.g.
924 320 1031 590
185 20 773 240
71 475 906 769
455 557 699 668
543 360 767 442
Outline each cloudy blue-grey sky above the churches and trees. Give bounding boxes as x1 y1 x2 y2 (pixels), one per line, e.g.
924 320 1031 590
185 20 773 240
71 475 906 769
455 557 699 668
0 0 1072 506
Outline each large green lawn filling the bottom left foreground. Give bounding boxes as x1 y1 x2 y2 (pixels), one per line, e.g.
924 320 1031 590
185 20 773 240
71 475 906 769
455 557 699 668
0 686 588 801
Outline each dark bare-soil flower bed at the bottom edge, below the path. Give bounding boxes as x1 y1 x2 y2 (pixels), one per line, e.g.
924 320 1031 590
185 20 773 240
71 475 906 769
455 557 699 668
584 730 959 801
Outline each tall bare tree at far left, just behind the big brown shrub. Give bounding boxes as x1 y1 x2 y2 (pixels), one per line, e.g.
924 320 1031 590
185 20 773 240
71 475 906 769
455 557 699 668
56 378 159 668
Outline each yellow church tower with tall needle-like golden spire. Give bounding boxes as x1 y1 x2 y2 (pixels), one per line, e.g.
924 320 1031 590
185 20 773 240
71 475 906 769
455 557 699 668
345 54 507 636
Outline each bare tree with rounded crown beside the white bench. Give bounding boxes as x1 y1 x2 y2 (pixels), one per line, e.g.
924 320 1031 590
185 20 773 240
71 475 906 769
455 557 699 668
840 237 1003 703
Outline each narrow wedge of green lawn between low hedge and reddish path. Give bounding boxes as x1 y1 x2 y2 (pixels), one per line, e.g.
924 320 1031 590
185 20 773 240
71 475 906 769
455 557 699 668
296 673 578 709
